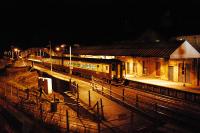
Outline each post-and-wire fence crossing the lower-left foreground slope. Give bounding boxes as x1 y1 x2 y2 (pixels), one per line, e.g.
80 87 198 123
0 82 102 133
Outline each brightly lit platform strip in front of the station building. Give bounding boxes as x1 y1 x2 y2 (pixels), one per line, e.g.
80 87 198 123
126 76 200 94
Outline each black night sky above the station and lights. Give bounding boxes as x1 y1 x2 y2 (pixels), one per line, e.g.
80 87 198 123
0 0 200 48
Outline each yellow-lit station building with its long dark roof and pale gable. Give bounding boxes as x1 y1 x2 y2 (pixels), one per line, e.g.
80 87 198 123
73 36 200 86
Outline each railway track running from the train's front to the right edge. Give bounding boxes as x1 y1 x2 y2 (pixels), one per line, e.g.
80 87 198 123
94 78 200 112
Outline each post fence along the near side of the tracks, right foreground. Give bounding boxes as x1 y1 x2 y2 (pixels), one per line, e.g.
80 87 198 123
92 78 200 130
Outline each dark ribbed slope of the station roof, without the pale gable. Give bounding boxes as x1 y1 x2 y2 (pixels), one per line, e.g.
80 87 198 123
72 41 182 58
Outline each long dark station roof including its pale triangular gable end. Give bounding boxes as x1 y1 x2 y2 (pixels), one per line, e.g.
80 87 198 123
67 40 200 59
